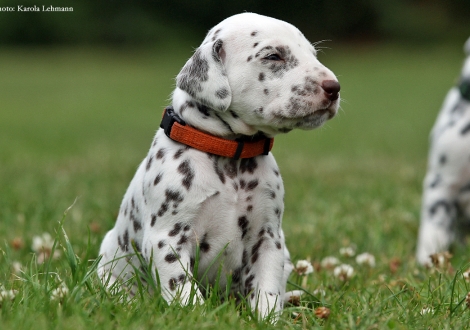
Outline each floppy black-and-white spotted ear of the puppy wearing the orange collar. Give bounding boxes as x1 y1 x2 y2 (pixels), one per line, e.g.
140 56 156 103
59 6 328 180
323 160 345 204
176 39 232 111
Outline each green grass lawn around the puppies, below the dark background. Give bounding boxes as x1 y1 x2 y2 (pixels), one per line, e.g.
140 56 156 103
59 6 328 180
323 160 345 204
0 42 470 330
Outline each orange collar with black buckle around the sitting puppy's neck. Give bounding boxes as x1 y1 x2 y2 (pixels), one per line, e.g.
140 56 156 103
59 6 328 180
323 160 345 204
160 106 274 159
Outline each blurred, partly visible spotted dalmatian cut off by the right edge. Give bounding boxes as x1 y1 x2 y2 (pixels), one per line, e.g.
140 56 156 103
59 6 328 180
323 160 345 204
416 38 470 265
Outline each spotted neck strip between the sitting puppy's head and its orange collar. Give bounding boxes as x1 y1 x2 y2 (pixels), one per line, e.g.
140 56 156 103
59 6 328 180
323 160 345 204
172 88 262 140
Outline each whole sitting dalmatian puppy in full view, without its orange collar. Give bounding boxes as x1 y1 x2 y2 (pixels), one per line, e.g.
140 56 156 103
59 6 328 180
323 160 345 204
98 13 340 318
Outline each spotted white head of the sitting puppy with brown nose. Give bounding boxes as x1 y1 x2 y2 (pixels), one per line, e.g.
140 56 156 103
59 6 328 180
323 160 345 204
176 13 340 135
